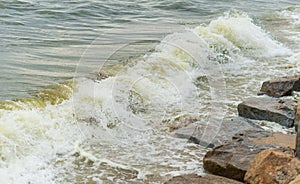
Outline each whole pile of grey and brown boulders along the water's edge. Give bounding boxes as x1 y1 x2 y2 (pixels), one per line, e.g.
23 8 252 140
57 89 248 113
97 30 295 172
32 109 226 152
166 75 300 184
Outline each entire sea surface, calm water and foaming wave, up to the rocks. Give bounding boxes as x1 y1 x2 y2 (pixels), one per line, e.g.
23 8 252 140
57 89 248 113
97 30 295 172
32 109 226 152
0 0 300 183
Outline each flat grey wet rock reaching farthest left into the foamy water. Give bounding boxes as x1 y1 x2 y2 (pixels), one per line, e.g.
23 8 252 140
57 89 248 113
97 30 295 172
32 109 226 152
173 117 263 148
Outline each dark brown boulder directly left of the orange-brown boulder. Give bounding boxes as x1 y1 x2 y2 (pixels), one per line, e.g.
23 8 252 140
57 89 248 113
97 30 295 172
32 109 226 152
203 130 290 181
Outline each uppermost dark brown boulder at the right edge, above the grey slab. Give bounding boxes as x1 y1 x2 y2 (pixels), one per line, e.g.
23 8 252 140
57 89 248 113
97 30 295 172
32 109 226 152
259 75 300 97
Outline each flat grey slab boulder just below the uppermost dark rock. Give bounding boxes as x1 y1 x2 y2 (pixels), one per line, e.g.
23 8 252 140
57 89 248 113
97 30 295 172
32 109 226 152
238 97 297 127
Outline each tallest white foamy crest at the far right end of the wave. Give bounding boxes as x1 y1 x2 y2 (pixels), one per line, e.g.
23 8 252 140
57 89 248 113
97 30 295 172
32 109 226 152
196 10 292 57
